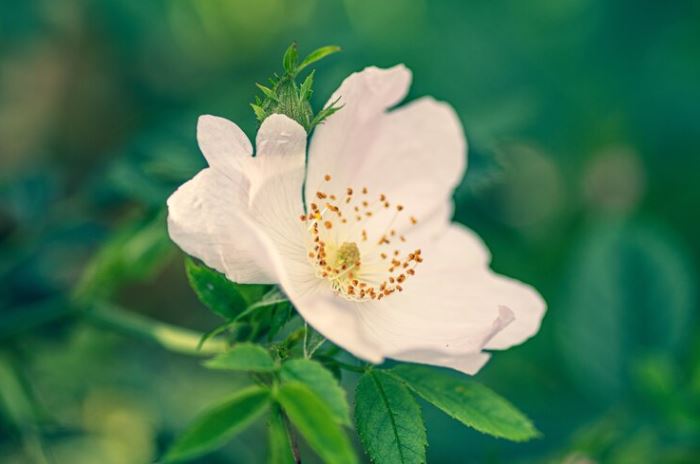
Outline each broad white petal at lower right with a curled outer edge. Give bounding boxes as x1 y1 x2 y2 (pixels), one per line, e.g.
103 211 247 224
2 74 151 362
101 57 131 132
356 225 544 372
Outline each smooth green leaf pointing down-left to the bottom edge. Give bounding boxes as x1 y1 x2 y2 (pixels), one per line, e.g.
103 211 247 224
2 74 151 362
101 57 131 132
164 386 270 462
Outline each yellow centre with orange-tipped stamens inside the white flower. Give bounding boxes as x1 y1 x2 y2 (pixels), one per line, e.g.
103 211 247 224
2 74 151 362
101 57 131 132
300 175 423 301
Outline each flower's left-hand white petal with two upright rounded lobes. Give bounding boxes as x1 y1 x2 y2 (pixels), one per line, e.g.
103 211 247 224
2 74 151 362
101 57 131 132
168 115 306 283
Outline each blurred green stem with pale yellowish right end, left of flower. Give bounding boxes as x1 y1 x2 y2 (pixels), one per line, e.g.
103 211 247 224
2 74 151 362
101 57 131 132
84 303 227 356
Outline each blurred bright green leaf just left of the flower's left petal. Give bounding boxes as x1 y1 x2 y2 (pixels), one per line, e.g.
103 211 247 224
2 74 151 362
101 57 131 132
75 211 173 300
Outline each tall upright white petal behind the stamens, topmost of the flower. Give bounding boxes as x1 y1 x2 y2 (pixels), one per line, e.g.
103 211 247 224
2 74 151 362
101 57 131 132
306 67 466 243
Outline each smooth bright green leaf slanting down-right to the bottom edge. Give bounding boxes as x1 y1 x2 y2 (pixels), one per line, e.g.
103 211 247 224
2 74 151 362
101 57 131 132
277 382 357 464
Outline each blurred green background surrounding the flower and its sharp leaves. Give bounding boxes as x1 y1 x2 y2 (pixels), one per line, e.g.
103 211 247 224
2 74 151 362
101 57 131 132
0 0 700 464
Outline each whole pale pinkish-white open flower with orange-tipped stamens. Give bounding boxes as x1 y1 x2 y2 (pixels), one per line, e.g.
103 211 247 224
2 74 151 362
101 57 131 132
168 65 545 374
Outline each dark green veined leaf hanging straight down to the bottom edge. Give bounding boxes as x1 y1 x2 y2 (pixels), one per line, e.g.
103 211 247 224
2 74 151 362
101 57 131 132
355 369 428 464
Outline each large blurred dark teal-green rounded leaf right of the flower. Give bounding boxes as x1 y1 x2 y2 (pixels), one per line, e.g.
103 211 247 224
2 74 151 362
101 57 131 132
558 222 696 399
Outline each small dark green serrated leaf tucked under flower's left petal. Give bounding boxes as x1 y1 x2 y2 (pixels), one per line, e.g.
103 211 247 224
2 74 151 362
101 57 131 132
185 257 248 319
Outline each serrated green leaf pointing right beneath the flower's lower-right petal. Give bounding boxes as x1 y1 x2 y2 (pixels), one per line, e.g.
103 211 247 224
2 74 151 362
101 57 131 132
388 364 539 441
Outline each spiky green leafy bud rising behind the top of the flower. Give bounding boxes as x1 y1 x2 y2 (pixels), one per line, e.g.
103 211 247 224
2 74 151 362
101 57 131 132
251 43 340 133
